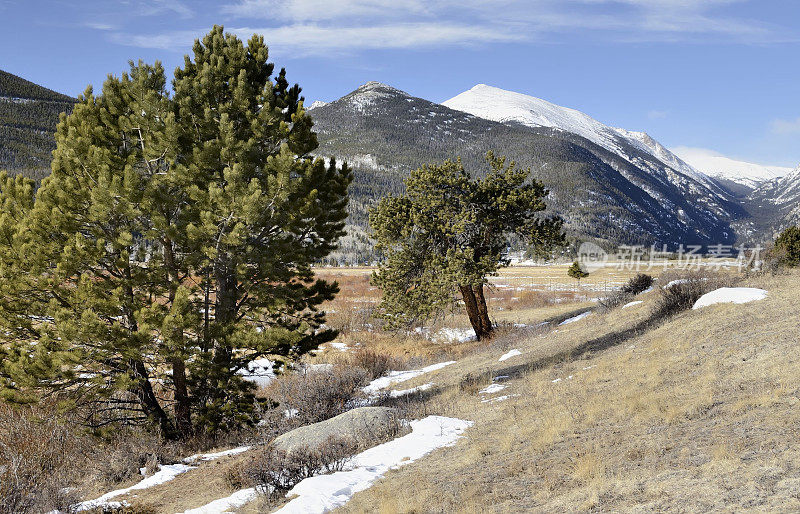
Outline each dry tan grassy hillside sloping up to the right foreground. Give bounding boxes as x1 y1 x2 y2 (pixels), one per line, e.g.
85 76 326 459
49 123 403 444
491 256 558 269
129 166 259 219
343 273 800 512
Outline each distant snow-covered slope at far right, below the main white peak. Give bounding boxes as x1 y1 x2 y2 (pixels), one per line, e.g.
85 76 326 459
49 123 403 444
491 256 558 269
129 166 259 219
672 146 792 188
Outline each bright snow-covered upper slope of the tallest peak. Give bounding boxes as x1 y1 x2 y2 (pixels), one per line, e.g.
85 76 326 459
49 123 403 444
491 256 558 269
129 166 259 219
443 84 708 184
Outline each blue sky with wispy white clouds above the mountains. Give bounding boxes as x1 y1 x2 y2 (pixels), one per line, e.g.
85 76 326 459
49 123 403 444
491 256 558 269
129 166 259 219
0 0 800 166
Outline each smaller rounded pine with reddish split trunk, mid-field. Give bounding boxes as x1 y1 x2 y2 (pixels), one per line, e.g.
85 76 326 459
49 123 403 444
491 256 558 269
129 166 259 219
370 152 564 339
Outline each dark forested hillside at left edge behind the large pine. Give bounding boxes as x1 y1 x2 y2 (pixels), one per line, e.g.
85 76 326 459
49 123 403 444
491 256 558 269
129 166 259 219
0 70 75 179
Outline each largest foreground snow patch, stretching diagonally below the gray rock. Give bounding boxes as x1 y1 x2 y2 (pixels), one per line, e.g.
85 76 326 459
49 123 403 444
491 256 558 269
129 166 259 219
272 416 472 514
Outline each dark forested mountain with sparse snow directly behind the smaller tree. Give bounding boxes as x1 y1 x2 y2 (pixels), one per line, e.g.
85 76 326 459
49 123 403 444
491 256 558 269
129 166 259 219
312 82 746 250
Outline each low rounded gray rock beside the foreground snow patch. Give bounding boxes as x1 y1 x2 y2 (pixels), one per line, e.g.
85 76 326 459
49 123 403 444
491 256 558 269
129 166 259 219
272 407 400 453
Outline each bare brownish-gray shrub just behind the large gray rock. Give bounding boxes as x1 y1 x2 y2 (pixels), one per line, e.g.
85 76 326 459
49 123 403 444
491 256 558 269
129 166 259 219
264 366 369 425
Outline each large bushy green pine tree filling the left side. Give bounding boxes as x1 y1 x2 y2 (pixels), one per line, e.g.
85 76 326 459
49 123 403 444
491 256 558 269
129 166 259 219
0 27 351 437
